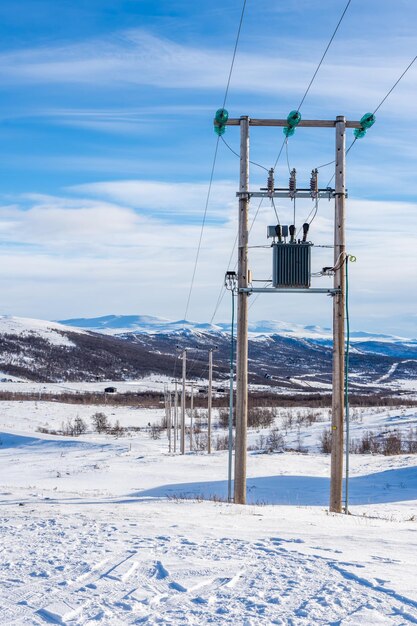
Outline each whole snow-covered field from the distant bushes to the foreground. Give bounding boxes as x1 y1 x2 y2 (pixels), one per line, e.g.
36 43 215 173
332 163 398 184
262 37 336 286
0 392 417 626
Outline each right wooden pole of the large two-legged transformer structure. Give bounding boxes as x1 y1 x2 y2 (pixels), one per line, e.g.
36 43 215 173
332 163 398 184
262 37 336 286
329 115 346 513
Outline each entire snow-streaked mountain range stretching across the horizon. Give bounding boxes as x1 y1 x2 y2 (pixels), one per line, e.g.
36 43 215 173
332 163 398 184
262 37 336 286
0 315 417 393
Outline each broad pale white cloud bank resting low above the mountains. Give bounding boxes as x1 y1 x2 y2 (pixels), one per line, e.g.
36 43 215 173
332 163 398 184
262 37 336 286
0 181 417 334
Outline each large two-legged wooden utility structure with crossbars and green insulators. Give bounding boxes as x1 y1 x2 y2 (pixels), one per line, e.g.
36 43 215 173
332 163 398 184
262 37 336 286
214 109 362 512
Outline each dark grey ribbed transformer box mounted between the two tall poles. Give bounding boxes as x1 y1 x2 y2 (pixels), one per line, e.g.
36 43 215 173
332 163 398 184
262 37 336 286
272 241 312 289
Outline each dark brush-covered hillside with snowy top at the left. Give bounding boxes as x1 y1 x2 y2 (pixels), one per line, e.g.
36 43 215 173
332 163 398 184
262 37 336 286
0 316 174 382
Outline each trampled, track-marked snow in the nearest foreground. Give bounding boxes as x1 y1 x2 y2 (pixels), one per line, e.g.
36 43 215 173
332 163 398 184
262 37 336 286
0 514 417 626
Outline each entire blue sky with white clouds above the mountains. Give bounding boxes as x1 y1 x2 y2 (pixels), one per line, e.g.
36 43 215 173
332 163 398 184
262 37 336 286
0 0 417 335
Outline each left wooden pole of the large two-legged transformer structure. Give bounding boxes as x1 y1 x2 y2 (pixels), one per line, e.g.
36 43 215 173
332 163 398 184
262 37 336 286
234 116 249 504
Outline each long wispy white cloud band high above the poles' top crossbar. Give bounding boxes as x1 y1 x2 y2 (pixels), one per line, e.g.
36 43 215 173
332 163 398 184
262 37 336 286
0 30 417 110
